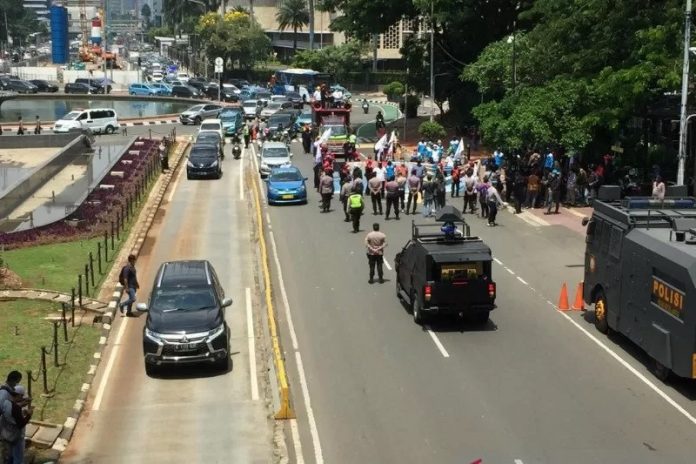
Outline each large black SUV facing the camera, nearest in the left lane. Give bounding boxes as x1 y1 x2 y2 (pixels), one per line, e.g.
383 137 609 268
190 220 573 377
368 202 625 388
137 260 232 375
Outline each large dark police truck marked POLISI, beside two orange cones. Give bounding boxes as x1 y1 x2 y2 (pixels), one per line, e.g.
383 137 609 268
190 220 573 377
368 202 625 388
583 186 696 380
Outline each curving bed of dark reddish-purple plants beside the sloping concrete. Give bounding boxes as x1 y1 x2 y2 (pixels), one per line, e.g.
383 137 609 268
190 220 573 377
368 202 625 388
0 138 160 249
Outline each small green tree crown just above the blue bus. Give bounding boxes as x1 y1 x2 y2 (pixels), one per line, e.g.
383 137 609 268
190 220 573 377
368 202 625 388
292 40 365 82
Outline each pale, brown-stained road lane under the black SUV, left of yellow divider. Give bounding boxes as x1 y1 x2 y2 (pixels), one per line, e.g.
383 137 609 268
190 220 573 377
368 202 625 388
61 140 273 464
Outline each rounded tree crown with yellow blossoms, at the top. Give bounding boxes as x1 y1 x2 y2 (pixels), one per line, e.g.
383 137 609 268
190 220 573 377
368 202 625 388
196 11 271 69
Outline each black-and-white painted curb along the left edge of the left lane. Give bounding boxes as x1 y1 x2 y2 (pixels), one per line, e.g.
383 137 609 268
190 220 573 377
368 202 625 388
52 142 188 453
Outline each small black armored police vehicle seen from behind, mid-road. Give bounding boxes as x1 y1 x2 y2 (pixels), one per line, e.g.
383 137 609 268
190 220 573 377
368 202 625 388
395 206 496 324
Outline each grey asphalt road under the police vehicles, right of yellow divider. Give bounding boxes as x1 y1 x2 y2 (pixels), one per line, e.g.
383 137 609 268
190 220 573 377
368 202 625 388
267 144 696 464
